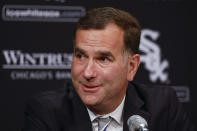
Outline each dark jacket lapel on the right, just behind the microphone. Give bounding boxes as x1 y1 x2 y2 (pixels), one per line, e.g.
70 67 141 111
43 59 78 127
123 83 150 131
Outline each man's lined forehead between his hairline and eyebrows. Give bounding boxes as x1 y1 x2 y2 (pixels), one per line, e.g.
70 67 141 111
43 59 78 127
75 24 123 51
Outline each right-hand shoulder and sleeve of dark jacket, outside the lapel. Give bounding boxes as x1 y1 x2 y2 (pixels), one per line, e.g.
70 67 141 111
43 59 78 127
129 84 194 131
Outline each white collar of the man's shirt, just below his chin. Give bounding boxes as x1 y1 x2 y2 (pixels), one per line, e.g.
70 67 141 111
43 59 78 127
87 96 125 124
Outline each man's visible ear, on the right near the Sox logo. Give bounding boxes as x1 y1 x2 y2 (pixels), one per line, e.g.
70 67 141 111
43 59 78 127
127 54 140 81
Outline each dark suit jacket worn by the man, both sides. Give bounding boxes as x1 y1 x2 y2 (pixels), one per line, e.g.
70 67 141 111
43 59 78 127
24 83 194 131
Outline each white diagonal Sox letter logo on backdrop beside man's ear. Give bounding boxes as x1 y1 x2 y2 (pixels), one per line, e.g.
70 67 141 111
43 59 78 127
140 29 169 83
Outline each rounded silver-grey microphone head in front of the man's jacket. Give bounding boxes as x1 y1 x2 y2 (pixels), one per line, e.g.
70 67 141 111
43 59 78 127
127 115 148 131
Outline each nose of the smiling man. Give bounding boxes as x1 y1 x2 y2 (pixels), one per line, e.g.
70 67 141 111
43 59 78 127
83 60 96 81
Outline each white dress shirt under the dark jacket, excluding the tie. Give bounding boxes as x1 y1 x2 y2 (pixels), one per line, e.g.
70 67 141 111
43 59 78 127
87 96 125 131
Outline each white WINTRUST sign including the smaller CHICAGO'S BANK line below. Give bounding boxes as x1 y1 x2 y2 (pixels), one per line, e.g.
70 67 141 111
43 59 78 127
2 50 72 80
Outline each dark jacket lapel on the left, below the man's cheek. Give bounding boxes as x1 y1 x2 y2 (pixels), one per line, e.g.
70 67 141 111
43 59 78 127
58 81 92 131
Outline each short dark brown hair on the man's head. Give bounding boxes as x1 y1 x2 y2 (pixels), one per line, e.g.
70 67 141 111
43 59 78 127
75 7 141 54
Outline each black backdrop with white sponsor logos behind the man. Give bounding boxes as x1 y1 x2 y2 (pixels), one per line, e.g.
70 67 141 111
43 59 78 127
0 0 197 131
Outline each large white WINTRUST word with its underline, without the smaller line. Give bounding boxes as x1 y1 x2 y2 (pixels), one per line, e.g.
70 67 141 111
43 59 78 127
3 50 72 69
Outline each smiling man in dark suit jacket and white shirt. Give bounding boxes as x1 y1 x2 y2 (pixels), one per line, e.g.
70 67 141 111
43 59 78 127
24 7 194 131
